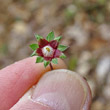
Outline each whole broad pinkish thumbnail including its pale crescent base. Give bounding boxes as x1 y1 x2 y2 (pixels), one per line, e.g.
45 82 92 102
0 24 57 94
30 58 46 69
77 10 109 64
32 69 91 110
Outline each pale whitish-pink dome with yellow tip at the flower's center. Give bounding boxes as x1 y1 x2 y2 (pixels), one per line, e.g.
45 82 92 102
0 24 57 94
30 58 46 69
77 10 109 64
42 46 54 57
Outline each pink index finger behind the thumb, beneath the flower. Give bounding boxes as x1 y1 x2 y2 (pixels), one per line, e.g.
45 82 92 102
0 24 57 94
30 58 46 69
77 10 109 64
0 57 66 110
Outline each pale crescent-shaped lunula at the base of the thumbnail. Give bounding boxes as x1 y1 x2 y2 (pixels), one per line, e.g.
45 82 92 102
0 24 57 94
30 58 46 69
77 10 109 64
34 92 71 110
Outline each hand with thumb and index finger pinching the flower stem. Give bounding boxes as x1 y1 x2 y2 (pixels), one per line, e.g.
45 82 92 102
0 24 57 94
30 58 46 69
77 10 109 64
0 57 91 110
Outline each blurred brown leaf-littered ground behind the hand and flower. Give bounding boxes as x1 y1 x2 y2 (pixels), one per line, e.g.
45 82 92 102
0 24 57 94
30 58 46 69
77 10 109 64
0 0 110 110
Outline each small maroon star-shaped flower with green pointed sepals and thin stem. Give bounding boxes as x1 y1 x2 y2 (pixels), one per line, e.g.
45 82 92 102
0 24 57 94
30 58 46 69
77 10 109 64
30 31 68 69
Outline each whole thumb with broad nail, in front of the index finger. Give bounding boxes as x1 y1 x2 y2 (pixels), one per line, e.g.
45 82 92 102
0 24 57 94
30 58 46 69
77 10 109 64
10 69 91 110
